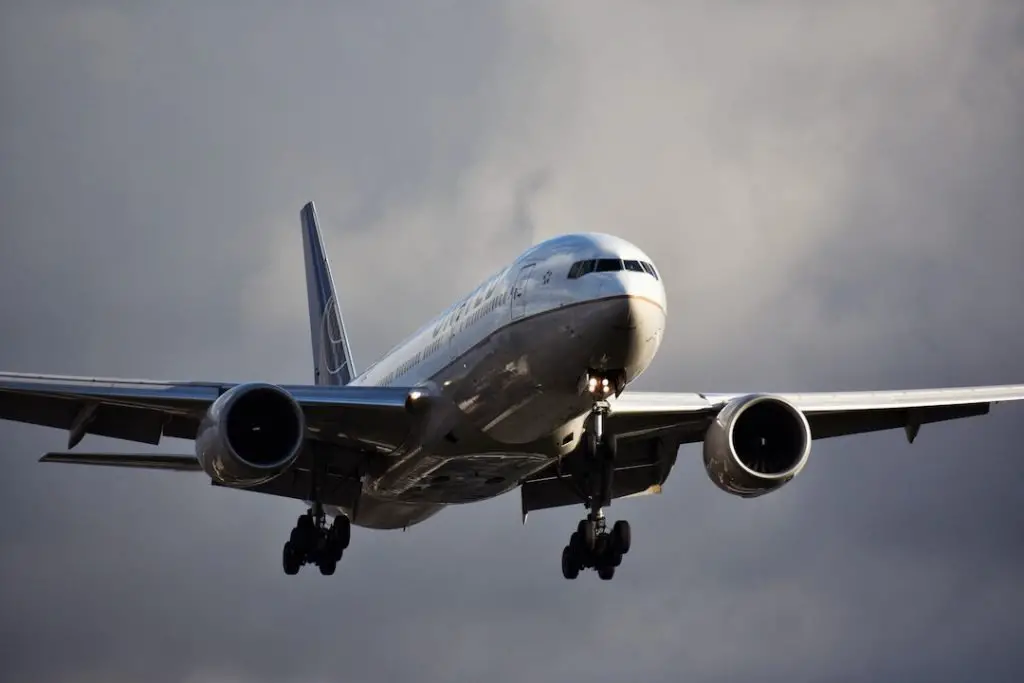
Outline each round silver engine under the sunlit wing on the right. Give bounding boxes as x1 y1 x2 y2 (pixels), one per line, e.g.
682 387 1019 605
703 394 811 498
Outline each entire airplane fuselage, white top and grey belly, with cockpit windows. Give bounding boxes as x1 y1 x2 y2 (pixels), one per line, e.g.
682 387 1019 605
337 233 667 527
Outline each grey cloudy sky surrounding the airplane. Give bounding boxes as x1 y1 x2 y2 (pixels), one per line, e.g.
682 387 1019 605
0 0 1024 683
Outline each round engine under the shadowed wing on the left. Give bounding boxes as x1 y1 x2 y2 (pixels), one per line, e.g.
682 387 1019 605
196 383 306 486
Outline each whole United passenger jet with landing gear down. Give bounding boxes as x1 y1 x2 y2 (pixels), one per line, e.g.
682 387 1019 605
0 202 1024 581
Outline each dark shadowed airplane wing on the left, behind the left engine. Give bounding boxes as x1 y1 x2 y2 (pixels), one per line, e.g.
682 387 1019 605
0 373 412 452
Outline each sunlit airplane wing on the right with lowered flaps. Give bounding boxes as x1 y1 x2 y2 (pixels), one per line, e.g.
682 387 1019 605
521 384 1024 517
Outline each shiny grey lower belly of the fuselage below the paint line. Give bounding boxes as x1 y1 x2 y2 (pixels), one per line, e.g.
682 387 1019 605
338 294 665 528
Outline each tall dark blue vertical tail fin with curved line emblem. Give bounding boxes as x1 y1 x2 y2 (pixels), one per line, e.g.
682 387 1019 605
300 202 355 385
